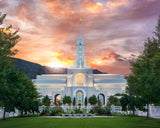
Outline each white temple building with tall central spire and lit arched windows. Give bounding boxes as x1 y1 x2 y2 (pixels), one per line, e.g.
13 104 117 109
33 22 127 106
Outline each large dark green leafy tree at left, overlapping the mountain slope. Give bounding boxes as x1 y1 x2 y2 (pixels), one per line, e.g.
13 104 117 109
0 14 38 119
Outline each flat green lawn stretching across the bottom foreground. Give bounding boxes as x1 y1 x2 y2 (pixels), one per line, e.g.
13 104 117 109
0 117 160 128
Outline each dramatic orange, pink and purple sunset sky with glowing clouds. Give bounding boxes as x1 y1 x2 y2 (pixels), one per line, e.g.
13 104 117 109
0 0 160 74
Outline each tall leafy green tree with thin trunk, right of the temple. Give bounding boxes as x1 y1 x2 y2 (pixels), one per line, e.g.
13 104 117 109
127 17 160 118
